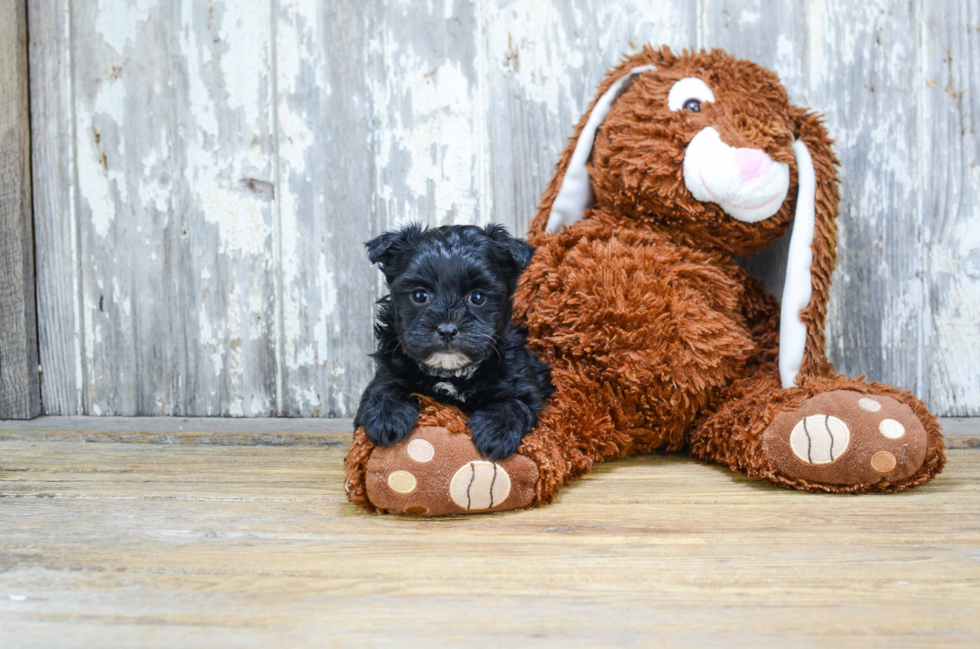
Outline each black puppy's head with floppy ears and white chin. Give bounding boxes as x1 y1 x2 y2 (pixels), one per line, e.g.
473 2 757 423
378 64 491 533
366 225 533 371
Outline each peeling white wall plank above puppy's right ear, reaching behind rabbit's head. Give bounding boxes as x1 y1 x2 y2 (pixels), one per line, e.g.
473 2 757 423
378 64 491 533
485 0 698 232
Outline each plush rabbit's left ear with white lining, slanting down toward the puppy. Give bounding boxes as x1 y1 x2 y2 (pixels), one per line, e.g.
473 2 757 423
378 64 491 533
528 47 673 244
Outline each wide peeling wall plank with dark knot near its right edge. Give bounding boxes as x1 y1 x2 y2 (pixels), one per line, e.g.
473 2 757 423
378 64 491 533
72 0 277 416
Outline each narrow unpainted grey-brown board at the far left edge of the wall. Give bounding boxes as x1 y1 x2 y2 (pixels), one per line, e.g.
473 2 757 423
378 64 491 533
0 0 41 419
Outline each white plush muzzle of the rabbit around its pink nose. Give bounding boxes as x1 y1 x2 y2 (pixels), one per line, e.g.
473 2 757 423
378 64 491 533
684 126 789 223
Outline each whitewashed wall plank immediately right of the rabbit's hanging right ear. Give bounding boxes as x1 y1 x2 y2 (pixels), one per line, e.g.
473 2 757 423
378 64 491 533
810 0 932 414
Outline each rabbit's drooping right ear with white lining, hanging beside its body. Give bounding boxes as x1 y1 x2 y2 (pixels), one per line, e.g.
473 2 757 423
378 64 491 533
779 107 840 388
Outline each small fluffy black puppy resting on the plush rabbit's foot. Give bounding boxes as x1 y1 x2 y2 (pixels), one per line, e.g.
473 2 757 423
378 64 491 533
354 225 553 461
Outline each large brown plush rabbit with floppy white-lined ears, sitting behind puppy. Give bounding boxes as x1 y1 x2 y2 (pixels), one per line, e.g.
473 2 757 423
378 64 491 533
346 48 945 515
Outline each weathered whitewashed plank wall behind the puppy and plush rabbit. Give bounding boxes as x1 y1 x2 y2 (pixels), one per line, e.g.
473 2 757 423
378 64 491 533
29 0 980 416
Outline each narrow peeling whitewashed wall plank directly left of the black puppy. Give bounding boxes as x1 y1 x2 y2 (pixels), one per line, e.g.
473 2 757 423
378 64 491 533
273 0 386 417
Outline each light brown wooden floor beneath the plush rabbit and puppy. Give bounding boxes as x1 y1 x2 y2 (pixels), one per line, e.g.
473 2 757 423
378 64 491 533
0 419 980 649
